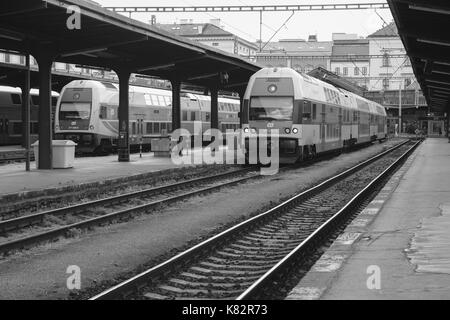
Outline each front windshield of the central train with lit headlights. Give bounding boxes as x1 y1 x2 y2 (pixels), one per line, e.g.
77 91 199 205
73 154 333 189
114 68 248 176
250 97 294 121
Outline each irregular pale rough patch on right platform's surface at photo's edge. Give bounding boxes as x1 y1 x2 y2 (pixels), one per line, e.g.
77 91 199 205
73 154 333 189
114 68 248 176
405 203 450 274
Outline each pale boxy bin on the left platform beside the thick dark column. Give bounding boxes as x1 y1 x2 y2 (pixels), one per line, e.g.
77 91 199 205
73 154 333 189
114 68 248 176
32 140 77 169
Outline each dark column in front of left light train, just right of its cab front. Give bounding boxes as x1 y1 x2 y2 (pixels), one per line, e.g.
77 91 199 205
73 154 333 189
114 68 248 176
116 70 131 162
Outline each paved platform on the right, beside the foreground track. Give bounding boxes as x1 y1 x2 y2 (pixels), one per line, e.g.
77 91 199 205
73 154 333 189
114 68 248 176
287 138 450 300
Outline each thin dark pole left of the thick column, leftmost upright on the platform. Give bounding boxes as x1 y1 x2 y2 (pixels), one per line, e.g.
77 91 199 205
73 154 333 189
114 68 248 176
22 54 30 171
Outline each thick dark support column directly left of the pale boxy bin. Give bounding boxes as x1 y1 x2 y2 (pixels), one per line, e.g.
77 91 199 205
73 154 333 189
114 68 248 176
36 54 53 170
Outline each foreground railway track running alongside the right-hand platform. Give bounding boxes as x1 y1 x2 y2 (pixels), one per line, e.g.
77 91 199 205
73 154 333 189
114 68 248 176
91 141 420 300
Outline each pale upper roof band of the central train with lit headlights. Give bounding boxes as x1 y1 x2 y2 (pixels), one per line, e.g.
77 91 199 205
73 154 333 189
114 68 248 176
246 68 386 116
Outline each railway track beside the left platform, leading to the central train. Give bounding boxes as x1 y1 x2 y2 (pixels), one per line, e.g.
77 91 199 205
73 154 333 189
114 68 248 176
0 168 260 254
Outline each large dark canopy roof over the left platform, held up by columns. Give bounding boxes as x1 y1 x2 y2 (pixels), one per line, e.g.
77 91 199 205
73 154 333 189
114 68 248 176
0 0 260 91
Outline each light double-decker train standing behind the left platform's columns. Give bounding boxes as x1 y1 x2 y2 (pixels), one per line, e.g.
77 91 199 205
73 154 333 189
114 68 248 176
55 80 240 154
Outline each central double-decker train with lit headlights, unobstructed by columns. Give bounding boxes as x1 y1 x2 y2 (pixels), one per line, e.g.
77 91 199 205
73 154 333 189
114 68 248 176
242 68 387 163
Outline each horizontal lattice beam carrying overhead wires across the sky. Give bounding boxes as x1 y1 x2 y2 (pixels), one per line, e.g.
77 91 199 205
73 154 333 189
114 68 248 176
105 2 389 13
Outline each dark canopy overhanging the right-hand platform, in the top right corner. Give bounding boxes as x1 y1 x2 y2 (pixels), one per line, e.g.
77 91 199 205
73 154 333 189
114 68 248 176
389 0 450 111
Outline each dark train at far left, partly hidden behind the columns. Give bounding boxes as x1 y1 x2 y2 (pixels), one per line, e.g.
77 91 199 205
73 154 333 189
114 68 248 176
0 86 59 146
